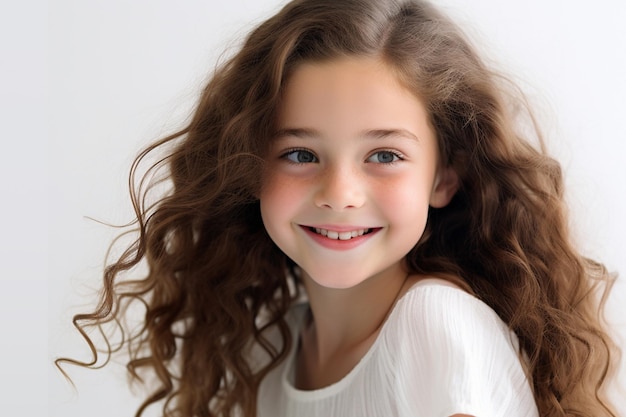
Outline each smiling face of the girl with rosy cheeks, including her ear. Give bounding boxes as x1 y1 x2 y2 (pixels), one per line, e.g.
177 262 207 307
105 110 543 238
260 58 457 288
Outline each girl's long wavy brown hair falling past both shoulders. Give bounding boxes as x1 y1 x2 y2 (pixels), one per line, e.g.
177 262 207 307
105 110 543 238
59 0 617 417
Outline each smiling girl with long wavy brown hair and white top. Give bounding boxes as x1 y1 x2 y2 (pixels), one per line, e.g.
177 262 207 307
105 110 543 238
54 0 615 417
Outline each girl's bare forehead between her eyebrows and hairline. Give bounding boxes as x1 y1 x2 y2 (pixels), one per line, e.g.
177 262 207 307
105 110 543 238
277 57 429 138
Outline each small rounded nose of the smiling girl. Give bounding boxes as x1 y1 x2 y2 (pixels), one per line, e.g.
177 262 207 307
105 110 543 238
314 167 366 211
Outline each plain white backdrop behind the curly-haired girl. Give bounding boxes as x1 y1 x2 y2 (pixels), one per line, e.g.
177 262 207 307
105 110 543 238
39 0 626 417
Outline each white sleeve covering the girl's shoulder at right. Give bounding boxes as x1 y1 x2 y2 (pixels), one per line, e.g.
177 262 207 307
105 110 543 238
388 284 537 417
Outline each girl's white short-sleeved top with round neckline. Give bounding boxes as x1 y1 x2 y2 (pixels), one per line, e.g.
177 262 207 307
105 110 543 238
258 279 539 417
